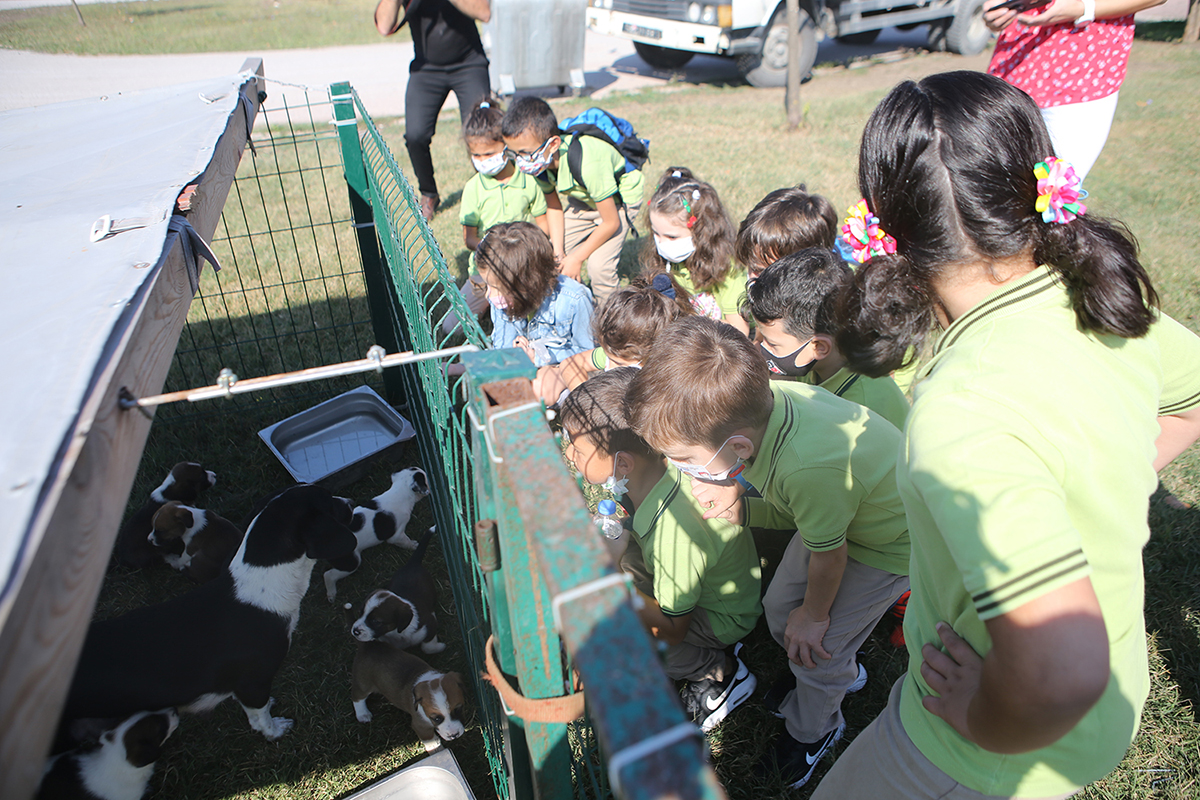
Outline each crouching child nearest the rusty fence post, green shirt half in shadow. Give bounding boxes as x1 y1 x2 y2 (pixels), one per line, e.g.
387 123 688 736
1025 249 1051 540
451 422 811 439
562 367 762 733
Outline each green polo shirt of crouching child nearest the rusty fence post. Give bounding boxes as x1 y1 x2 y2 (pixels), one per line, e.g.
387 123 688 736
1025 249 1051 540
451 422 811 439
634 464 762 644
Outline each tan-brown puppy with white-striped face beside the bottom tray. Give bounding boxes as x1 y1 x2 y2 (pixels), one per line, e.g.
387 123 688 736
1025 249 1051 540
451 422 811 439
350 642 464 751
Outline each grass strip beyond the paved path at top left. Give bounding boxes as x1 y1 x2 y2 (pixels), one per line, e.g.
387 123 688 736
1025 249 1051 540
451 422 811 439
0 0 409 55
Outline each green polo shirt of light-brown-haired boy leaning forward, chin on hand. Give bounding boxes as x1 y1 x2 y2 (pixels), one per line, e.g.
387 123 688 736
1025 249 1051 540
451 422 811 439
743 381 908 575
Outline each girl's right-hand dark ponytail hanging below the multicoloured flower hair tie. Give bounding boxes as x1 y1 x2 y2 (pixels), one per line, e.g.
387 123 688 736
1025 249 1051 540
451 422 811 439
1034 216 1158 338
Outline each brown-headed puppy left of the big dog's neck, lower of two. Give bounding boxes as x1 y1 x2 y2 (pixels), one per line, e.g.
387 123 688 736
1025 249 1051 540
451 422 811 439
150 500 242 583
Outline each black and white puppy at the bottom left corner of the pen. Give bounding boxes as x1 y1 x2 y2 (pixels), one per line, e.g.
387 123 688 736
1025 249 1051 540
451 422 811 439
37 709 179 800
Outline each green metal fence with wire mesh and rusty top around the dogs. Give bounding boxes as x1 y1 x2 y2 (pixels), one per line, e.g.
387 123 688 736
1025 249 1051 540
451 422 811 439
157 84 724 800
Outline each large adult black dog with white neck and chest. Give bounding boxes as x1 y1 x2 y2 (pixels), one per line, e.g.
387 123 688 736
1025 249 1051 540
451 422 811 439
62 483 354 739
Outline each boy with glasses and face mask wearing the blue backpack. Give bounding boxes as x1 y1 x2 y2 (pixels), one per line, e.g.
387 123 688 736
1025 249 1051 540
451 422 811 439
503 96 643 303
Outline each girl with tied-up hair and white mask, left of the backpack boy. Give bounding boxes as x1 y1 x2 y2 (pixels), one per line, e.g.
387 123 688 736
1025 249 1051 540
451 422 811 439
443 97 550 331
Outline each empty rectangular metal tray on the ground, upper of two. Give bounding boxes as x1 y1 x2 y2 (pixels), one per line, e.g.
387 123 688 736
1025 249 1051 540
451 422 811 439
258 386 416 485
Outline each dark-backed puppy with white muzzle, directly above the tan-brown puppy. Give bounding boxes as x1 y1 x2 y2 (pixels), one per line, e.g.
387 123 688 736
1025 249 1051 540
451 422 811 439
350 528 446 652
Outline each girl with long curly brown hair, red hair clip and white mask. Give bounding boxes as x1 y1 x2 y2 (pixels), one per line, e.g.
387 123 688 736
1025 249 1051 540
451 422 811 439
642 167 750 333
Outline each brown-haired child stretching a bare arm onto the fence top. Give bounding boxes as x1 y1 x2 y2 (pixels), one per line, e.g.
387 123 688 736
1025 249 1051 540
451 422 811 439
533 275 692 405
